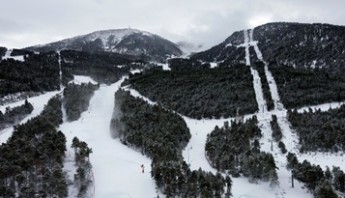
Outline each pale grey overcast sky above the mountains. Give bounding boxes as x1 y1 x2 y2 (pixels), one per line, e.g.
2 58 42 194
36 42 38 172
0 0 345 48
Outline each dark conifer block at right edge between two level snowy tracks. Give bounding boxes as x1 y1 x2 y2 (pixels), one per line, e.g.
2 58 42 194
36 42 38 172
288 105 345 152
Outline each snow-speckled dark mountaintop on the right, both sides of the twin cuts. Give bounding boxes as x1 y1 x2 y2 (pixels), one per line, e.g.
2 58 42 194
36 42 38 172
192 23 345 68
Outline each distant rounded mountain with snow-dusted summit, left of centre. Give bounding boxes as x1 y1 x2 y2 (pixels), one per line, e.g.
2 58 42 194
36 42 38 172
25 28 182 60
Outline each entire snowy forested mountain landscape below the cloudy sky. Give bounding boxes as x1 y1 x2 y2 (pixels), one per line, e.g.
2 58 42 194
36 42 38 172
0 23 345 198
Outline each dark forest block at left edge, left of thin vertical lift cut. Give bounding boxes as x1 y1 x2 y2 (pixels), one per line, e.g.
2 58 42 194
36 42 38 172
0 52 60 97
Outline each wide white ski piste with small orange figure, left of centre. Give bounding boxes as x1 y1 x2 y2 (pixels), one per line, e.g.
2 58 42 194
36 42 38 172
60 80 157 198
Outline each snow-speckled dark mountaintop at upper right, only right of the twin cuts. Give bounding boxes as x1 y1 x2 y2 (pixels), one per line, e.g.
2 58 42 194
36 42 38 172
253 23 345 68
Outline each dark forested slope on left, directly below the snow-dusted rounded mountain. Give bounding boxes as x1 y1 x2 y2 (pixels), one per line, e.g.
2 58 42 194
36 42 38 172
0 48 142 104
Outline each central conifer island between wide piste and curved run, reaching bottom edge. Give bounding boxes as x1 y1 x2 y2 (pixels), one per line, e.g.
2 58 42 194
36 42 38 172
111 90 231 197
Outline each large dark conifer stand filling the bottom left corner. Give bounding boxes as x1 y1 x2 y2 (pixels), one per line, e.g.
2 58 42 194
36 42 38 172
0 96 67 197
